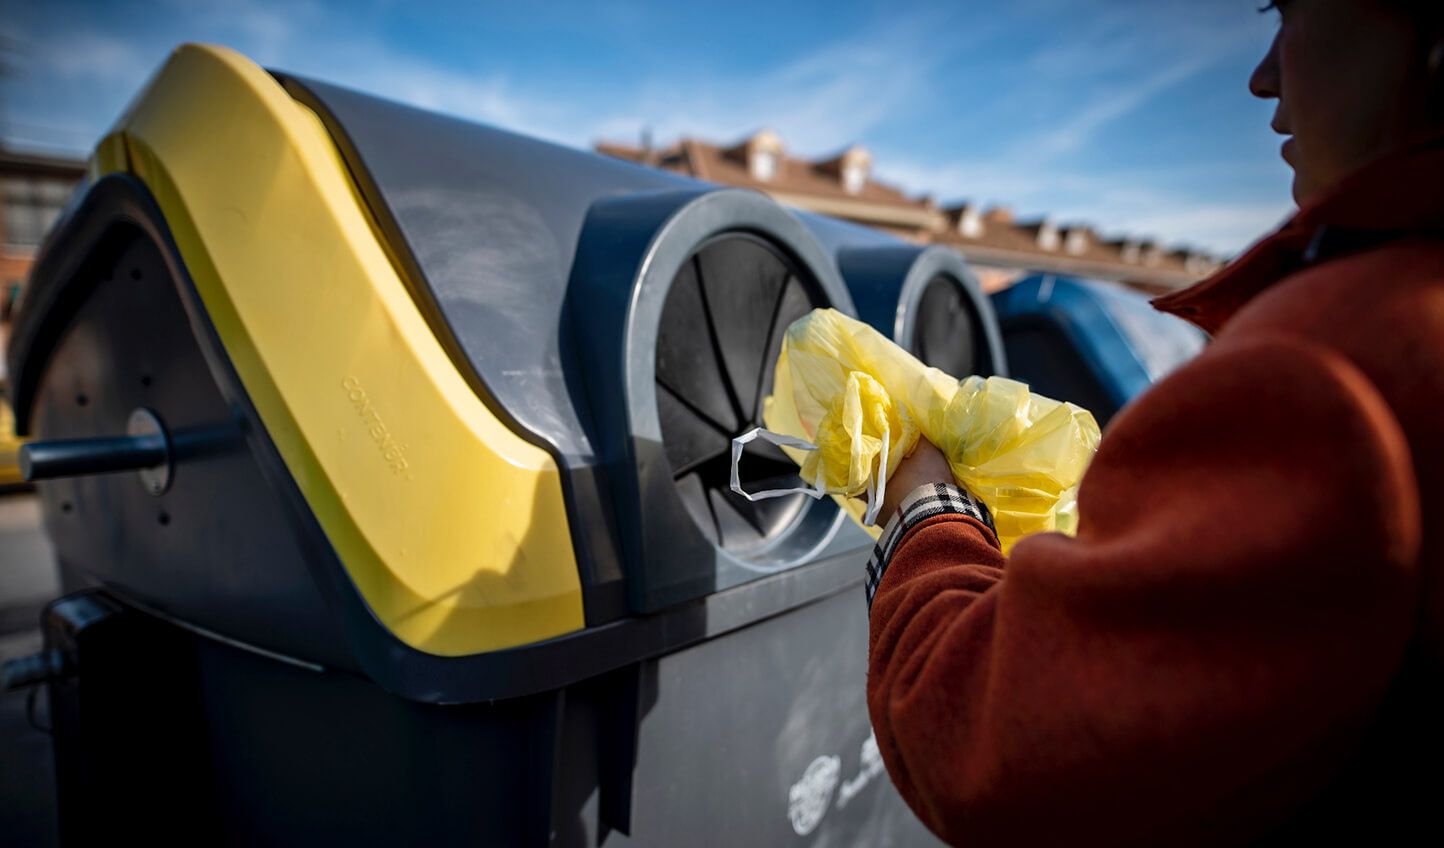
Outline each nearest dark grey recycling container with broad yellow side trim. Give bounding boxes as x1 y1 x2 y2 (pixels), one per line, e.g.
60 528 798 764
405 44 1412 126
7 46 933 845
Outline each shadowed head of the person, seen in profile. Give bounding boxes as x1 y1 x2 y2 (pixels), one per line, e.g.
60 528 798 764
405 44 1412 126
1249 0 1444 205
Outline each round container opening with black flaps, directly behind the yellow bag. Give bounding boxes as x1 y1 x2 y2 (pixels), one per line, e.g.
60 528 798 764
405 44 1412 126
657 233 826 555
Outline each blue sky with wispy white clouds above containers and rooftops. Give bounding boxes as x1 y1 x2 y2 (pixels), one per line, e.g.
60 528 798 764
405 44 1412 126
0 0 1289 254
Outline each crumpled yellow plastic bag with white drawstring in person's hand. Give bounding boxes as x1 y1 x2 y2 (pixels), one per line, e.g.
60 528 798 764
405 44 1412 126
732 309 1099 552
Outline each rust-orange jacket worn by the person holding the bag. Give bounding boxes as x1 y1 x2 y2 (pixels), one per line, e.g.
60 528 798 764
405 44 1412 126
868 135 1444 847
